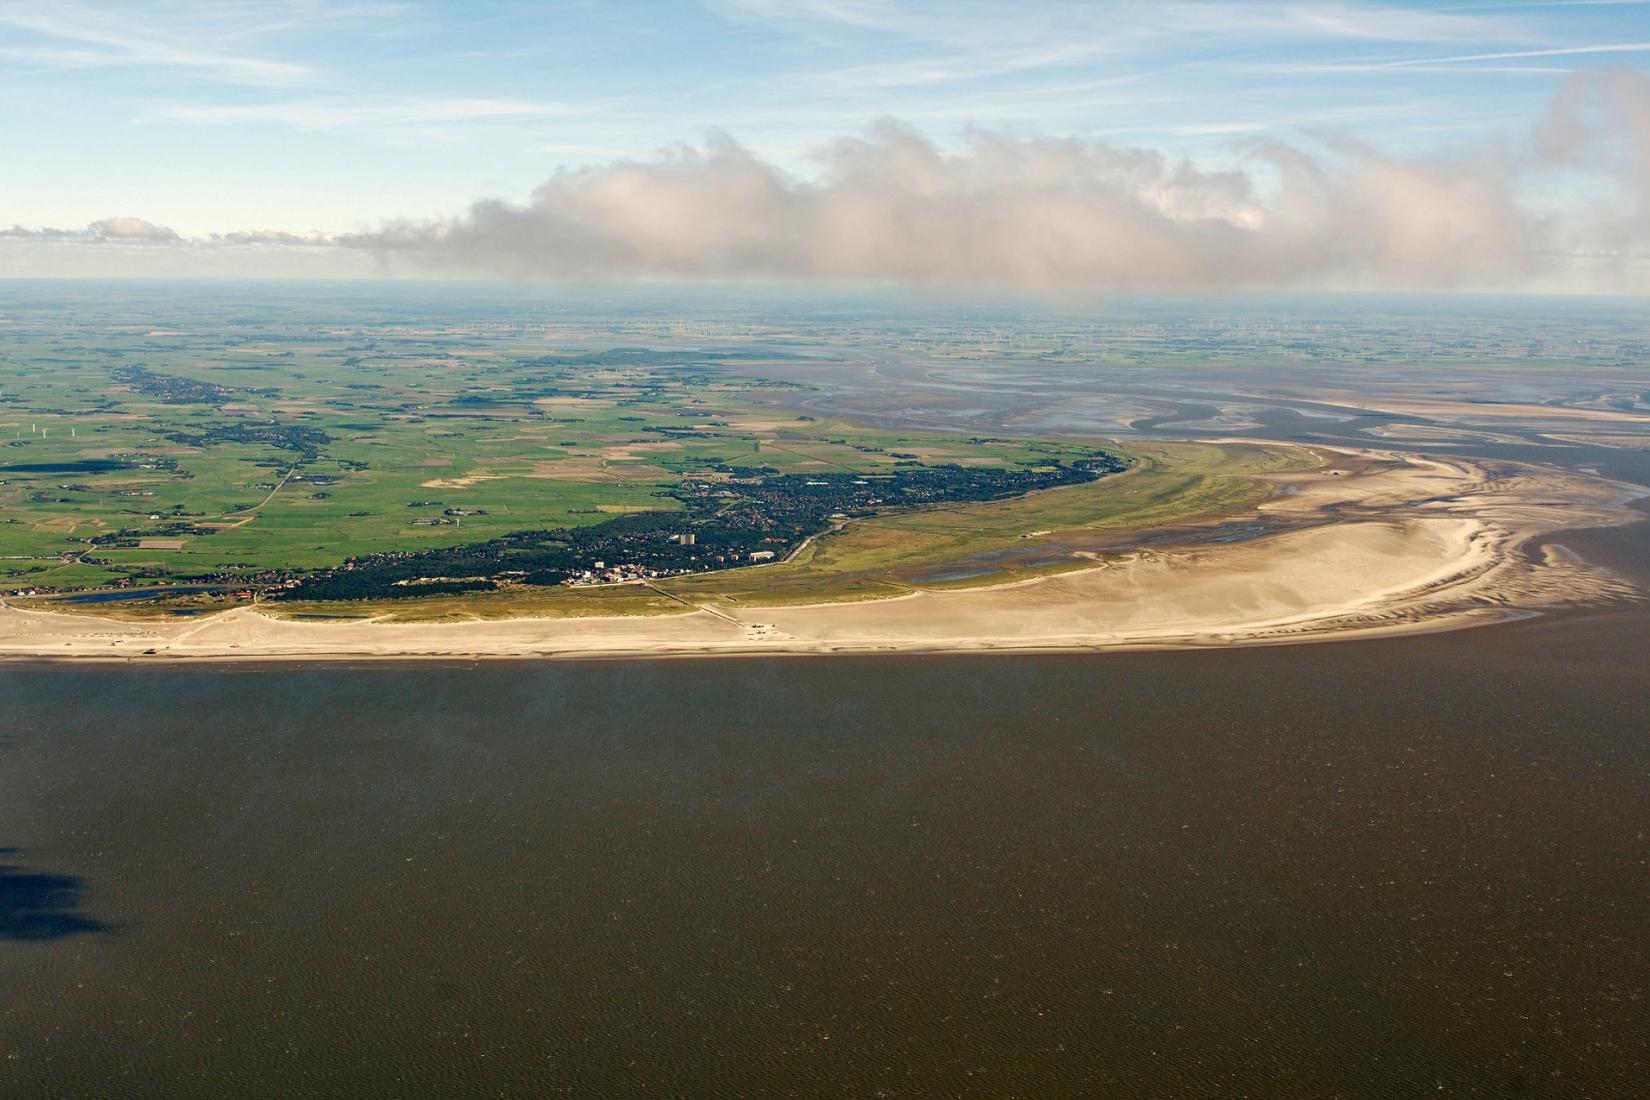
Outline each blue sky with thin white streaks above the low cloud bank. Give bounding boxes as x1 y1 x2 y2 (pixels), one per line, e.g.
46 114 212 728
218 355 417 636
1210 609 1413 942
0 0 1650 286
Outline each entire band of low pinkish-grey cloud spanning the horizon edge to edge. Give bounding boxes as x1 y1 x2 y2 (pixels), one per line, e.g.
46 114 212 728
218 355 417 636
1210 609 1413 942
0 71 1650 292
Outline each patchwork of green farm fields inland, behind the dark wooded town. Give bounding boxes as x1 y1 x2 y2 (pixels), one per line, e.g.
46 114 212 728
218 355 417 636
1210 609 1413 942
0 335 1092 590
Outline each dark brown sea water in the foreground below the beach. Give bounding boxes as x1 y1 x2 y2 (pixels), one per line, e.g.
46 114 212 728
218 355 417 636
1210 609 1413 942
0 583 1650 1097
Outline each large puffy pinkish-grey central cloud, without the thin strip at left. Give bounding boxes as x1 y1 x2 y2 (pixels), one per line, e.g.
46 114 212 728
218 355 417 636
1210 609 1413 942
340 124 1541 290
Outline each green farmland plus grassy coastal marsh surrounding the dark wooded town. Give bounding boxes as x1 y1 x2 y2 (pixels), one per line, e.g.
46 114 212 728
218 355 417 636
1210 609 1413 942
0 288 1315 618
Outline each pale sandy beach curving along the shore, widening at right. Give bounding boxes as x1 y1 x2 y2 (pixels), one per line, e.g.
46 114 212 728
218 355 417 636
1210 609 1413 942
0 452 1640 661
